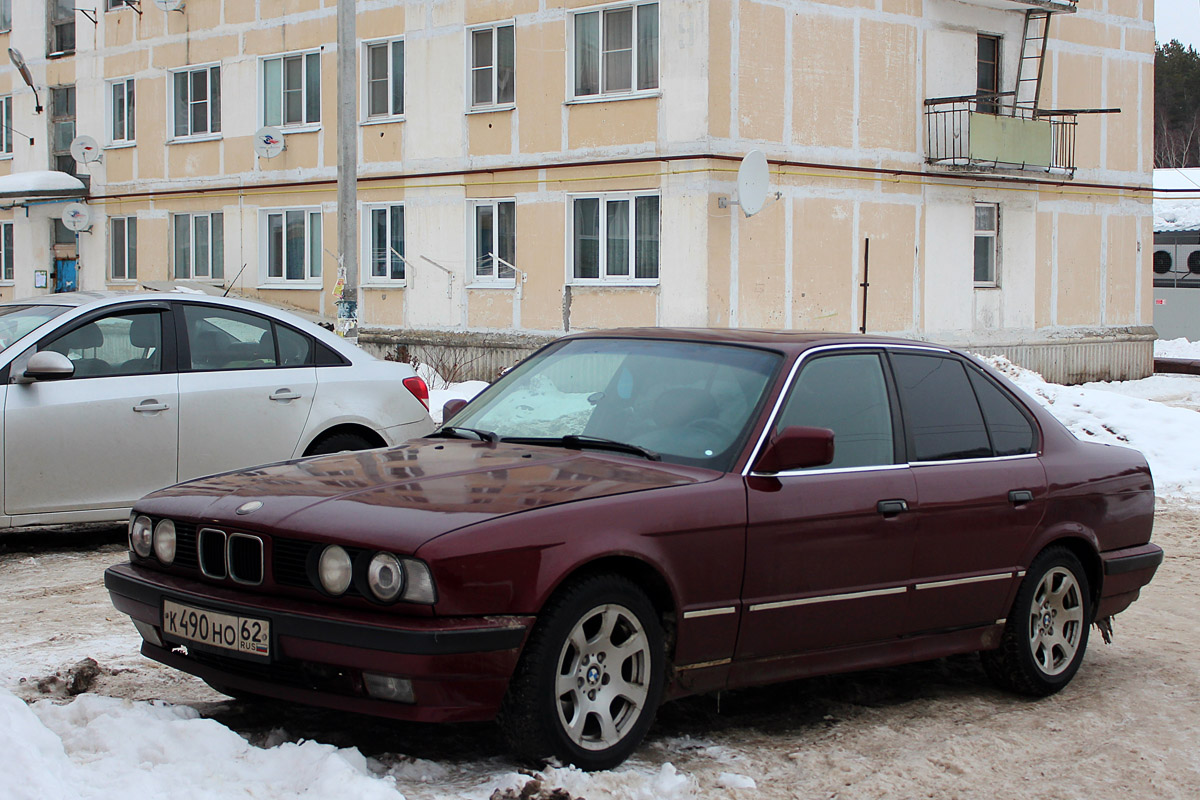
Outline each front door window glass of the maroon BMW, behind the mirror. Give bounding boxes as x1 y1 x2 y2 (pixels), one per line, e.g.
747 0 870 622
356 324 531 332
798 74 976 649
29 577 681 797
775 353 895 469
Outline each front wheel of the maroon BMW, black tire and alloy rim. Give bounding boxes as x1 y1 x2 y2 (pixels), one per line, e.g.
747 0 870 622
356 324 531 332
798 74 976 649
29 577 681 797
499 575 666 770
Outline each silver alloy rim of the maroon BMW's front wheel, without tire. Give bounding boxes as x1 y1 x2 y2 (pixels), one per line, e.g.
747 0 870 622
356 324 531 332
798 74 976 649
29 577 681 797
556 603 650 750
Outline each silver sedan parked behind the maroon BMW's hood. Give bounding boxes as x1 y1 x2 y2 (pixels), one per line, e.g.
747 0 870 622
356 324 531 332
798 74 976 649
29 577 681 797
0 293 433 528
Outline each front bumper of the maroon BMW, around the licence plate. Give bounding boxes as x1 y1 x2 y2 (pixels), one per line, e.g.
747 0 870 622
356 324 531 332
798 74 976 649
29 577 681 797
104 564 533 722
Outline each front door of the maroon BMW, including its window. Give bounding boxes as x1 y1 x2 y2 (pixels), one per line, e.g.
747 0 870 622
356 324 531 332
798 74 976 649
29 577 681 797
736 349 917 674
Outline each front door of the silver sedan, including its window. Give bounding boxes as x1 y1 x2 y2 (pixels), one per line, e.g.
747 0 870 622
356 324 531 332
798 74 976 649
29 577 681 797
4 312 179 515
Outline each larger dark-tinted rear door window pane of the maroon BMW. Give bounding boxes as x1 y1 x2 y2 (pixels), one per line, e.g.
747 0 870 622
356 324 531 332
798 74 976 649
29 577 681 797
892 353 991 461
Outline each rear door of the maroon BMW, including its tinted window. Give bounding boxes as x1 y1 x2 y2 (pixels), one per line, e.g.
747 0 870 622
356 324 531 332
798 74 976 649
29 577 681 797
890 350 1046 633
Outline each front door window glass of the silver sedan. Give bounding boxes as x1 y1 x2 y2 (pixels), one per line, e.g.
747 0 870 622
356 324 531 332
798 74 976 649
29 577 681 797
41 312 162 378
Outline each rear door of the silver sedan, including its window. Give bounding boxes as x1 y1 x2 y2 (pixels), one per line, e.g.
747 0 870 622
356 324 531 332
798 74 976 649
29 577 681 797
176 303 317 481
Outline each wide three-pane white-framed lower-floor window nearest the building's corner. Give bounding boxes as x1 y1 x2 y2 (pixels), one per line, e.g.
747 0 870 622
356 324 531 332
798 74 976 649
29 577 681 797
571 193 659 283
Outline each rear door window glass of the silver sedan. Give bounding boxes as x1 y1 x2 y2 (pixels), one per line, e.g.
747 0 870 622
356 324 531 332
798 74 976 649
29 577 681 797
184 305 277 369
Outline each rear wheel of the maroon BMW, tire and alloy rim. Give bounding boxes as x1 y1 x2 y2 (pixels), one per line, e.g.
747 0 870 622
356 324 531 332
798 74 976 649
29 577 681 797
980 547 1092 697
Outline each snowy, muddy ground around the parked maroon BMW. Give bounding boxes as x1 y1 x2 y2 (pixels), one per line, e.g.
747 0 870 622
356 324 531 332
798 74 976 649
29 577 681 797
0 342 1200 800
